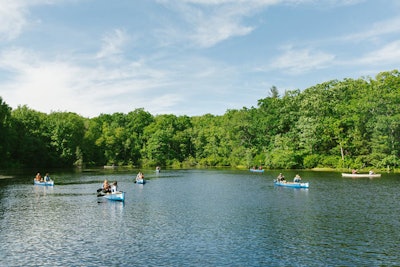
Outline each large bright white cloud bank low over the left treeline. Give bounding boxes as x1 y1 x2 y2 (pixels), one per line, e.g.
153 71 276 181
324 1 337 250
0 45 197 117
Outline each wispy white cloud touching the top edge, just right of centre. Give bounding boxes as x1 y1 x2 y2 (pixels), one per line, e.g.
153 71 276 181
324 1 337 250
158 0 364 48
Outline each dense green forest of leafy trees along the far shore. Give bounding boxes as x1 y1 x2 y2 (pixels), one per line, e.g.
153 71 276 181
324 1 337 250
0 70 400 169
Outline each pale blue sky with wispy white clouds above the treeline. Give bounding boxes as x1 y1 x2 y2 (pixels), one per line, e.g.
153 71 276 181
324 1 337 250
0 0 400 117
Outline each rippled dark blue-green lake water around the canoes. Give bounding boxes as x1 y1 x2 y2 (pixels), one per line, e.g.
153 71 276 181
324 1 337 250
0 170 400 266
